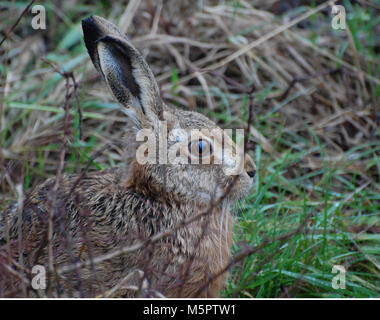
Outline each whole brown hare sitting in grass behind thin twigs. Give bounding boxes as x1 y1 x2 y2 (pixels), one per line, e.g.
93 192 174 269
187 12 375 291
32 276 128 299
0 16 255 297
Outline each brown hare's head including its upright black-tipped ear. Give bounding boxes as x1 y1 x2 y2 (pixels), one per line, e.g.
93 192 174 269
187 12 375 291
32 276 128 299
82 16 255 208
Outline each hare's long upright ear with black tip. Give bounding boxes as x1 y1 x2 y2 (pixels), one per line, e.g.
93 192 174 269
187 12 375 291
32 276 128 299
82 16 162 122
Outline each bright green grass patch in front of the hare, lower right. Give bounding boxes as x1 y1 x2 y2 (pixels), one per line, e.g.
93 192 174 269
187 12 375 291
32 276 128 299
226 139 380 297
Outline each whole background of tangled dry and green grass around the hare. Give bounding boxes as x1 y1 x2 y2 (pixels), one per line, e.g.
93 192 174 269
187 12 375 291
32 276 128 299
0 0 380 298
